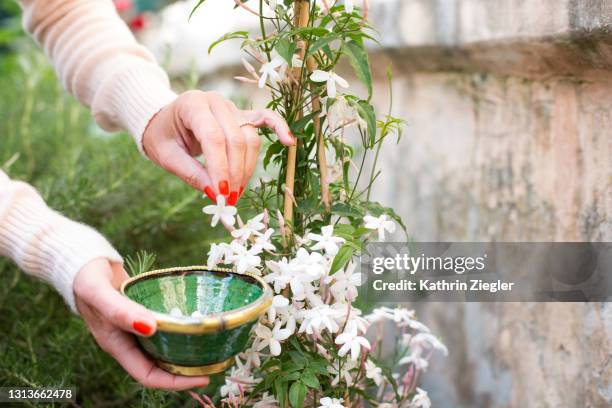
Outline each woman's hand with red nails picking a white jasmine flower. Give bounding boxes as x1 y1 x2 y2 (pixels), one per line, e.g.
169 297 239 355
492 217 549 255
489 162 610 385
142 91 296 205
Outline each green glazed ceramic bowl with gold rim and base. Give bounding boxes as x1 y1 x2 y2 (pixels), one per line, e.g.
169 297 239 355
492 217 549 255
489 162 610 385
121 266 272 376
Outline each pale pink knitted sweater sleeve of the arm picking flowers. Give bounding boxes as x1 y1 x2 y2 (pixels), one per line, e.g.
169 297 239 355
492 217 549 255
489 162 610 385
20 0 176 152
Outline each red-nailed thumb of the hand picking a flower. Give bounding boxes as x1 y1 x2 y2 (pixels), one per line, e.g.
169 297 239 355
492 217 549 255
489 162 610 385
162 143 217 202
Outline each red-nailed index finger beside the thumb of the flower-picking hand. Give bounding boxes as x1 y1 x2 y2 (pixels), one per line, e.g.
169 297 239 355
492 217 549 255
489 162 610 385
186 104 230 197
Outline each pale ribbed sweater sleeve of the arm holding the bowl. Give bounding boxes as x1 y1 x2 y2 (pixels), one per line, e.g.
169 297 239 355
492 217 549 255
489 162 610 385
0 183 123 313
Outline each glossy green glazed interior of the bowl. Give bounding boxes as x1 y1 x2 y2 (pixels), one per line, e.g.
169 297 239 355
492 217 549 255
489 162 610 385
125 269 264 320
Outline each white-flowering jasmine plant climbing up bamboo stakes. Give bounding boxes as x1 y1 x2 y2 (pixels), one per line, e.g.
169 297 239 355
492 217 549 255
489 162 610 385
186 0 446 408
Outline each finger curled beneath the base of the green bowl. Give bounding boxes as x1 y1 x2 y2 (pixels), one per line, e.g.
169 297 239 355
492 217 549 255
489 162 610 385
100 333 208 391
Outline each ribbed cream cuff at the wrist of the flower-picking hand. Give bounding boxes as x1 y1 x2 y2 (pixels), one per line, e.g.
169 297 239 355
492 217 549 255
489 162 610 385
92 56 177 154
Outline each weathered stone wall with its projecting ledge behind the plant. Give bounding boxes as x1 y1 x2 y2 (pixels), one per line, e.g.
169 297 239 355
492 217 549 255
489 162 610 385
145 0 612 408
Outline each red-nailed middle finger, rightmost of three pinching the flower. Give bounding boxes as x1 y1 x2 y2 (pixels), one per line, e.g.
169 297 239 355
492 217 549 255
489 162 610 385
209 94 246 205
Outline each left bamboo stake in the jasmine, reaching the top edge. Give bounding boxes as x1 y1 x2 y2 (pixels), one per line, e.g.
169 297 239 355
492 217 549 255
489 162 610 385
283 0 310 244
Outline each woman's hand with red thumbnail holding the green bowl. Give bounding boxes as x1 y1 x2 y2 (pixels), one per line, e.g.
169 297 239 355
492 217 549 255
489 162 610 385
73 259 208 390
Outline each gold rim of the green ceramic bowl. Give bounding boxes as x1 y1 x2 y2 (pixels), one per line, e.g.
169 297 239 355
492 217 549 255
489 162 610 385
120 265 272 334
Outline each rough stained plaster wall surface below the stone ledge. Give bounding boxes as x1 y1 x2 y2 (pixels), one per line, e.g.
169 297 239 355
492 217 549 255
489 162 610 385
364 24 612 408
